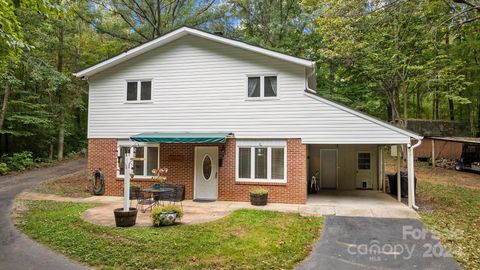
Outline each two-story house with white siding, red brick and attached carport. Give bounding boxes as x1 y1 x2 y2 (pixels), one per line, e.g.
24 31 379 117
75 27 421 204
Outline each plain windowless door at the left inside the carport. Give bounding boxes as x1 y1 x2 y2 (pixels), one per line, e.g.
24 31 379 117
320 149 337 189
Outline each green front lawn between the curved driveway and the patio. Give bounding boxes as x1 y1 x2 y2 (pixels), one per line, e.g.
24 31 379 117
18 201 323 269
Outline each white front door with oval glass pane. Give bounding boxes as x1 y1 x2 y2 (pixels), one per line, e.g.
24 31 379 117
194 146 218 200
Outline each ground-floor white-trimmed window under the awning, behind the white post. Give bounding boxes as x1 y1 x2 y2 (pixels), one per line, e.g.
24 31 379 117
117 142 160 178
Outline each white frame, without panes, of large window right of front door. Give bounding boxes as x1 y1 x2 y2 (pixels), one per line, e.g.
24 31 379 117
235 140 288 183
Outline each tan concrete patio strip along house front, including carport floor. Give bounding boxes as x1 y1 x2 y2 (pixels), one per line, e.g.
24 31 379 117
18 190 418 226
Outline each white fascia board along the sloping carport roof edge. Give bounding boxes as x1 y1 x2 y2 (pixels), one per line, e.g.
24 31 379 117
305 90 423 140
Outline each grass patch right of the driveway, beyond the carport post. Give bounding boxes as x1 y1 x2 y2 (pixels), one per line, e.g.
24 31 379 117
418 181 480 269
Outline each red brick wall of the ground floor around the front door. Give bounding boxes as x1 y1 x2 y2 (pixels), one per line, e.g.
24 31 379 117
88 139 307 204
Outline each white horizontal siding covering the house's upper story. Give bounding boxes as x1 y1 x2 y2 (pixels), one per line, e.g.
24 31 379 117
88 35 410 144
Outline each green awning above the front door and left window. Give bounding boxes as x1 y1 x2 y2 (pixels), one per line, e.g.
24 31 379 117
130 132 230 143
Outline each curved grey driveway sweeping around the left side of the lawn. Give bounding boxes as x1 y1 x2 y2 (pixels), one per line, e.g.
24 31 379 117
0 159 87 270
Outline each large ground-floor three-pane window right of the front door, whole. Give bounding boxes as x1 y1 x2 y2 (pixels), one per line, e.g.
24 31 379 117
236 141 287 183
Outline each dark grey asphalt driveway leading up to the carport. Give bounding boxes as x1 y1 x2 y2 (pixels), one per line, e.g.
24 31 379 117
297 216 461 270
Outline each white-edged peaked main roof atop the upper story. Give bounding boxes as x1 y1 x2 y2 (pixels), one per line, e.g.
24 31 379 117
73 26 315 77
